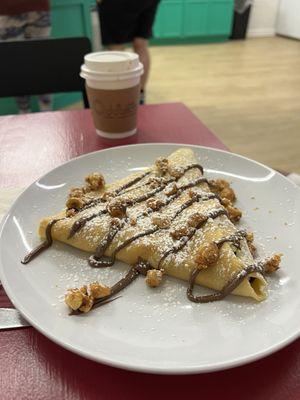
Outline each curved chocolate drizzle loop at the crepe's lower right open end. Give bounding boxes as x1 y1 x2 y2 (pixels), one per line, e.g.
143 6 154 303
187 261 265 303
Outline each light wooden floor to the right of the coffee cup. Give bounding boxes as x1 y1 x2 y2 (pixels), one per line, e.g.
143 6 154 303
68 37 300 173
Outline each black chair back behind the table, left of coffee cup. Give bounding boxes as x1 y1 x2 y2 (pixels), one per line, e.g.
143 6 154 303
0 37 91 108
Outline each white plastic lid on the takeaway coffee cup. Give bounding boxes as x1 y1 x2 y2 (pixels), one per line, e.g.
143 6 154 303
81 51 143 79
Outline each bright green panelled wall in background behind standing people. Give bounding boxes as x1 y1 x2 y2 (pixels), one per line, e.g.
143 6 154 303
0 0 234 115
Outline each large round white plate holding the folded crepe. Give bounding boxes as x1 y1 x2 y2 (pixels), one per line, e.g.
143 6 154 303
0 144 300 374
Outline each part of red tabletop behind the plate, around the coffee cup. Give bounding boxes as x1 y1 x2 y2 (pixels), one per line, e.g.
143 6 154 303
0 103 226 187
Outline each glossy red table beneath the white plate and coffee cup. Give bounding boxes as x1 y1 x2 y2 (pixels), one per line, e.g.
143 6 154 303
0 104 300 400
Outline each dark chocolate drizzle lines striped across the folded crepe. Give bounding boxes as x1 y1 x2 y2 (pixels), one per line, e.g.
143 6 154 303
22 159 264 307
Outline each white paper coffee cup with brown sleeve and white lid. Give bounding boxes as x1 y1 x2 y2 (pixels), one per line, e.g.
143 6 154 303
80 51 143 139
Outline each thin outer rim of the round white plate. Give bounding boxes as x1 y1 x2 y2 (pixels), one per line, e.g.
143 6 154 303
0 142 300 375
